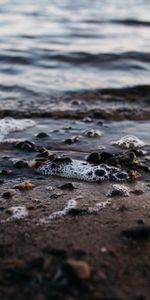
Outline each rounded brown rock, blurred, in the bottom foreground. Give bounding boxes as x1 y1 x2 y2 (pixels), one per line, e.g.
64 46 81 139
62 259 91 280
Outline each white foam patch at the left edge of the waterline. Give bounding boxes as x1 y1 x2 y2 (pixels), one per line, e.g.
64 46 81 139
0 117 35 142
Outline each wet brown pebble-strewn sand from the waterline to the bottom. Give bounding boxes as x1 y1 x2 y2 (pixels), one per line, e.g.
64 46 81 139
0 111 150 300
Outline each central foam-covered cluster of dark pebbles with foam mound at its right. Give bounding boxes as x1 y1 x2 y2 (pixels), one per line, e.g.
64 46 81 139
37 136 149 182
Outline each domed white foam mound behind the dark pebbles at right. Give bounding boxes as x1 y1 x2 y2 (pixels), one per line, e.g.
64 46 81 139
111 135 145 149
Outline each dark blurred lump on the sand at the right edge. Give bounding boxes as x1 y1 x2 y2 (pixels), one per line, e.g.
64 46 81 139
121 225 150 240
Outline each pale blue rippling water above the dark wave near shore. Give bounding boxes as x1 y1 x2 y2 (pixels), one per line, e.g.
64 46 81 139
0 0 150 106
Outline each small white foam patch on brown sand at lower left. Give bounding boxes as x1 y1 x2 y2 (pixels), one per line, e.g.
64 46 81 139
6 206 28 221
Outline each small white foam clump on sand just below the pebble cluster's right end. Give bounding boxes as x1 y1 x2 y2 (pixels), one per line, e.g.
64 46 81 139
107 184 130 197
